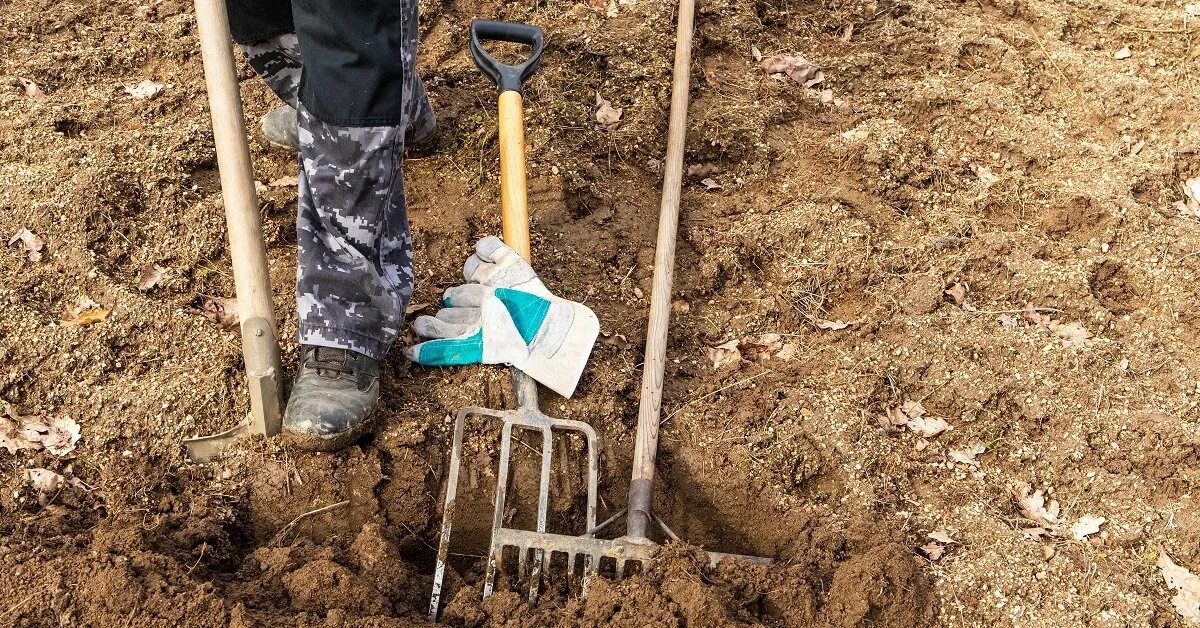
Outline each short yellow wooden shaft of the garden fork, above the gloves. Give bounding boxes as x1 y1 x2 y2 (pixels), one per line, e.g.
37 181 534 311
499 90 533 262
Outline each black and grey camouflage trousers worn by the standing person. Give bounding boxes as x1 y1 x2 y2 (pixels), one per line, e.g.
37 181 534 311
229 0 434 359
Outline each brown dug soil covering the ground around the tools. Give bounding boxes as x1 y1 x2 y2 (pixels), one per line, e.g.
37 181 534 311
0 0 1200 627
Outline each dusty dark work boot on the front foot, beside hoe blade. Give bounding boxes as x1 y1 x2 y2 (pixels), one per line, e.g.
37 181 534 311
283 346 379 451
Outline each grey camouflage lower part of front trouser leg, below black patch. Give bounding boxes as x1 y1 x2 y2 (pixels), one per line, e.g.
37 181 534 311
296 103 413 359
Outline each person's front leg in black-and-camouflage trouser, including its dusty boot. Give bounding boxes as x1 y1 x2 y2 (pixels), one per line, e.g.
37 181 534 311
284 0 432 449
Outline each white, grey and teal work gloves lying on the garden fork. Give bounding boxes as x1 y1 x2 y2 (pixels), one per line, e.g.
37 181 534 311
406 235 600 397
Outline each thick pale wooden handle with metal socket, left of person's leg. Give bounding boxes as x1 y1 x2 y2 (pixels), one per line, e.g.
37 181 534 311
196 0 283 436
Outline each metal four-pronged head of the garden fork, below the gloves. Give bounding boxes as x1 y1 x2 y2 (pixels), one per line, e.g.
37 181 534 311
430 381 600 621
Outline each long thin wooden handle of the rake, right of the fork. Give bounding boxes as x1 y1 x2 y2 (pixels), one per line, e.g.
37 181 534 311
628 0 695 537
